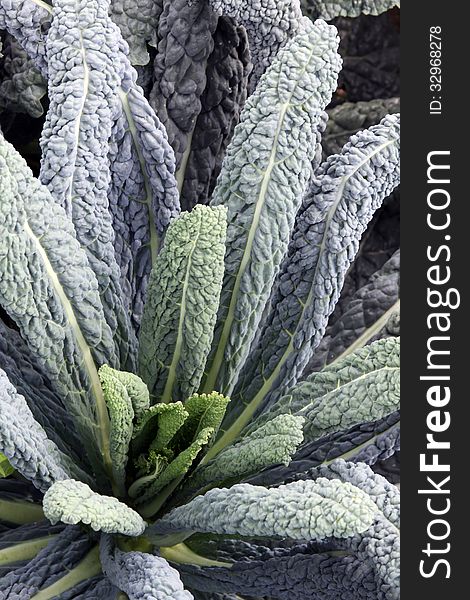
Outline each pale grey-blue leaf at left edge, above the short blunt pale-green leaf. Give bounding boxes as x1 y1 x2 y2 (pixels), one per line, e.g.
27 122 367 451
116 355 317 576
0 370 86 492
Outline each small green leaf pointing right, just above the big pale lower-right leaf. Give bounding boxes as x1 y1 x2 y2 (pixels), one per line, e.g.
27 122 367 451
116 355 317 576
188 415 304 487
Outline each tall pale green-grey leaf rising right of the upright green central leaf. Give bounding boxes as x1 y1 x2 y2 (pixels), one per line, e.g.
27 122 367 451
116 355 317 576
204 21 341 395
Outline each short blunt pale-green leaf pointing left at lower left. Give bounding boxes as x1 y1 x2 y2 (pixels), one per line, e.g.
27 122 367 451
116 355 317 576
43 479 145 536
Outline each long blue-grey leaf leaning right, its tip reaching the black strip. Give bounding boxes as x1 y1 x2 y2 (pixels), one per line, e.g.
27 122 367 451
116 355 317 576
224 115 400 450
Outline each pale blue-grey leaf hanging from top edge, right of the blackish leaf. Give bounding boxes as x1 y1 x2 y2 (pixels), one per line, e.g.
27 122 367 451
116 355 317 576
209 0 305 92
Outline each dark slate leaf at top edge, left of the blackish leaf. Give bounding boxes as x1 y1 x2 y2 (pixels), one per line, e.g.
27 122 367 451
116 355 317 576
150 0 217 177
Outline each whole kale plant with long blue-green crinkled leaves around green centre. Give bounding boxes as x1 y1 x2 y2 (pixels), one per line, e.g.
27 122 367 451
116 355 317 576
0 0 400 600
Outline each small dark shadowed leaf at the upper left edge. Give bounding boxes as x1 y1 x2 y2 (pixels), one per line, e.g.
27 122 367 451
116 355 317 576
0 34 47 117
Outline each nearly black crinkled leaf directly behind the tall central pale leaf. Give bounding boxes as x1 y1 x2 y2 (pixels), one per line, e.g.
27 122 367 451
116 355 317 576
181 16 252 210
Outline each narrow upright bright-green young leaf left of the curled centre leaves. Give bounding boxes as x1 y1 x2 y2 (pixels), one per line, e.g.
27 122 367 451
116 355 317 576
98 365 134 496
